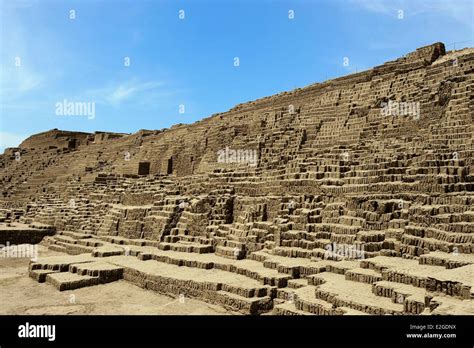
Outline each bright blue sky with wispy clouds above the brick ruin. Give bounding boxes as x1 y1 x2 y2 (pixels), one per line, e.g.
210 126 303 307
0 0 474 152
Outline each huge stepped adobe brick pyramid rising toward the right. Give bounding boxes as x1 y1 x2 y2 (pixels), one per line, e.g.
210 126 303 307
0 43 474 315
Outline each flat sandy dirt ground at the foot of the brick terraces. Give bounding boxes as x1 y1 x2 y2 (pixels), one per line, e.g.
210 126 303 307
0 245 230 315
